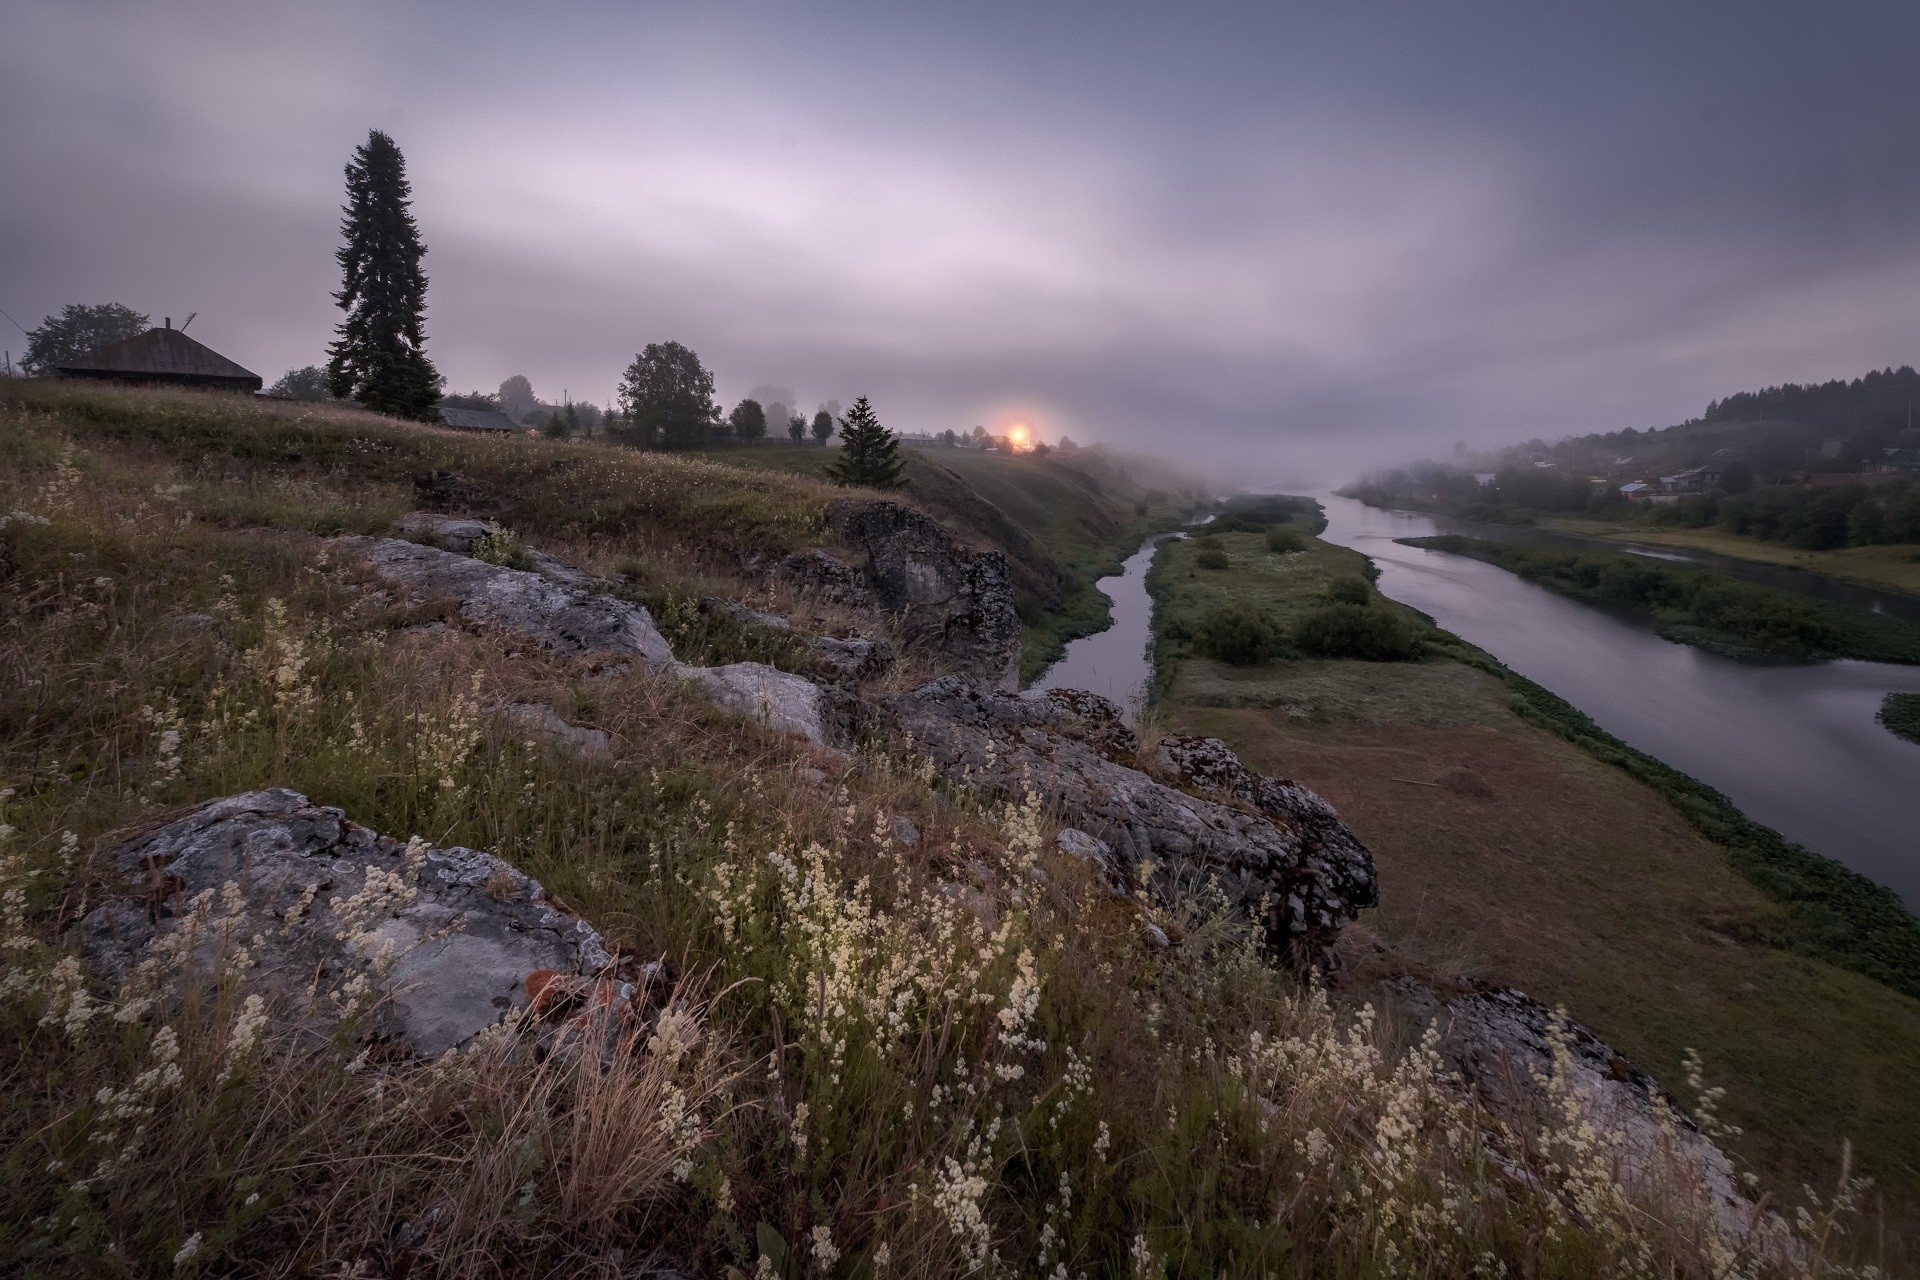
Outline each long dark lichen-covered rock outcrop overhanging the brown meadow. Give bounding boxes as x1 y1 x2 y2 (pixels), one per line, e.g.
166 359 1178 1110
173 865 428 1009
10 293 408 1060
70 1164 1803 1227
887 676 1379 961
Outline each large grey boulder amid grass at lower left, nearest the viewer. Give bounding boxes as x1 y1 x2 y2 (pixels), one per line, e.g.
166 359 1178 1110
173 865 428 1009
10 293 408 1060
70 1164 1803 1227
83 789 614 1057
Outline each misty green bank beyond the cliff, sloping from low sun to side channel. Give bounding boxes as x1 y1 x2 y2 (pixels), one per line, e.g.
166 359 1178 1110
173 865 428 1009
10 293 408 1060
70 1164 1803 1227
699 443 1210 679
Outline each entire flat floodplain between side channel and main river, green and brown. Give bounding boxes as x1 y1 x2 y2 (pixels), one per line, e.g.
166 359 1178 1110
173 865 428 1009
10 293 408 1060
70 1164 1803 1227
1148 506 1920 1213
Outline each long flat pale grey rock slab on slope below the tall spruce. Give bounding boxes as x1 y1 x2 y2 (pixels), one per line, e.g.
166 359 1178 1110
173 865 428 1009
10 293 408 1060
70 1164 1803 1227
334 537 674 670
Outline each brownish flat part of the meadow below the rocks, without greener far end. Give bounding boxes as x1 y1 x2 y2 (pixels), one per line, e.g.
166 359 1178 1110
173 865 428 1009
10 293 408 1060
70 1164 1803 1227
1175 690 1920 1232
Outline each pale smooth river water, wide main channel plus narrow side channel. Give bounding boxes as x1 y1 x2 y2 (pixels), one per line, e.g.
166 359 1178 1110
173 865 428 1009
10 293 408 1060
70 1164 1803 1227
1037 493 1920 906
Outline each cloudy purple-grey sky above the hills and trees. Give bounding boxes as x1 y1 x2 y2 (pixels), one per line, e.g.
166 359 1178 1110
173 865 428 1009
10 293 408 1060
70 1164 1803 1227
0 0 1920 482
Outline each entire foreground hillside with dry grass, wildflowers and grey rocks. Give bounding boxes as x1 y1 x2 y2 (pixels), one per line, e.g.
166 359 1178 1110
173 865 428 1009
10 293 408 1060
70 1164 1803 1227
0 382 1897 1280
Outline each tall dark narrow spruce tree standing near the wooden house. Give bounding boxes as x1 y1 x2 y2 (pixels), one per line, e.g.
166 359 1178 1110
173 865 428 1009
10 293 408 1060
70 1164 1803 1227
326 129 440 422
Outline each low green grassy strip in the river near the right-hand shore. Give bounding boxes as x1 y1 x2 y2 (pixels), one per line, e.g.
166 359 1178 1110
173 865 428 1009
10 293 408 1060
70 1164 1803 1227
1398 533 1920 662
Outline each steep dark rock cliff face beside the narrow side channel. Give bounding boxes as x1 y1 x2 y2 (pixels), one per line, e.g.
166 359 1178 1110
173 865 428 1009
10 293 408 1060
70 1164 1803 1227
828 501 1020 691
